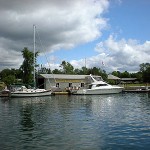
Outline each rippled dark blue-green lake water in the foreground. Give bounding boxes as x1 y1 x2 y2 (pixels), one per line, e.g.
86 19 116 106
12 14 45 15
0 93 150 150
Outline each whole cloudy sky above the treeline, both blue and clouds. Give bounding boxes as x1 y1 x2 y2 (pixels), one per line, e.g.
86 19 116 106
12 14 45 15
0 0 150 72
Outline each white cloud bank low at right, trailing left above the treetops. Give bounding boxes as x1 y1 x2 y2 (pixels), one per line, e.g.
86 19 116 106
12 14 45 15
71 35 150 72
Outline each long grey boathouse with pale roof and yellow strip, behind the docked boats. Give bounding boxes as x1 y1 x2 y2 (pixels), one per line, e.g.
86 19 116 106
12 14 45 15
37 74 102 91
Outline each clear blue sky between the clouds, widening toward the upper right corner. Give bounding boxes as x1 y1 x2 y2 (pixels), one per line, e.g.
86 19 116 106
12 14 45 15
44 0 150 72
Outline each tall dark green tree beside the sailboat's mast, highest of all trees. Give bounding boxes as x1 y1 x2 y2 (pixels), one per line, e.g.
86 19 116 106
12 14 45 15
20 47 38 84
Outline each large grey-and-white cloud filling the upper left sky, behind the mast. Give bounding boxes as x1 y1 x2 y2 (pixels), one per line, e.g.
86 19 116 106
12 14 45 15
0 0 109 70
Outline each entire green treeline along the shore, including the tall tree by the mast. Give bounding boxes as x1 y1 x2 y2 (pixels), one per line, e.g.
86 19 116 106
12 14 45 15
0 47 150 85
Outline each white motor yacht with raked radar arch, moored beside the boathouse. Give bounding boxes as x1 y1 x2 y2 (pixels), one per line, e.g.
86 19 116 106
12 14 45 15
73 75 123 95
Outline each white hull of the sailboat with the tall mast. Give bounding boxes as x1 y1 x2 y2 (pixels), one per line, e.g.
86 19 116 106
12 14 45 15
10 90 52 97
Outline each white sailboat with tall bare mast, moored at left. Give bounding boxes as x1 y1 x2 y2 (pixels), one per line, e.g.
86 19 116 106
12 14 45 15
10 25 52 97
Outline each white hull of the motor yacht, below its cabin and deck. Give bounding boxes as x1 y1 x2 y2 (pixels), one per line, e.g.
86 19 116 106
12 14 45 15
74 87 123 95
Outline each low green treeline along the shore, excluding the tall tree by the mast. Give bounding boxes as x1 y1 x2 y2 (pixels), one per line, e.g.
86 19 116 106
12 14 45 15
0 61 150 85
